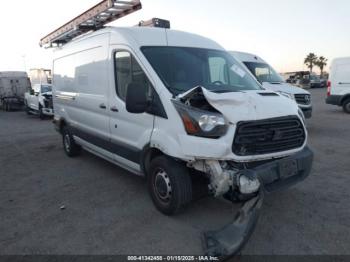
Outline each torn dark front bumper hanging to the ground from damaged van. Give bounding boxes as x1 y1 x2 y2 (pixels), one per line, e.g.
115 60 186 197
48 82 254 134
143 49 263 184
203 147 313 258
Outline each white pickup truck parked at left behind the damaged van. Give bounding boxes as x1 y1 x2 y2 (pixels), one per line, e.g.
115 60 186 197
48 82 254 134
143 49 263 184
24 84 53 119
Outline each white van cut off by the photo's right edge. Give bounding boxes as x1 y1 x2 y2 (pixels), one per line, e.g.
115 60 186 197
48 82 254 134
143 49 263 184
326 57 350 113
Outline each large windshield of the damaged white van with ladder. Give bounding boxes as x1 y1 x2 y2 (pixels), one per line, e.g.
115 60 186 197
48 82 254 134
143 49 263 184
141 47 261 95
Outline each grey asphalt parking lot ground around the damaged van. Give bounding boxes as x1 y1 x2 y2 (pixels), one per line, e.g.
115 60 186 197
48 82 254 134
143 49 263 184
0 89 350 254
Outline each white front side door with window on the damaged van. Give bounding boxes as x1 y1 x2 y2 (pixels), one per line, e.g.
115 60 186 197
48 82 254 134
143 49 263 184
109 46 154 171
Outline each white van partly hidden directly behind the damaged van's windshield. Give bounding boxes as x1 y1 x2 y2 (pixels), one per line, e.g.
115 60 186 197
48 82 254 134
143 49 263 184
229 51 312 118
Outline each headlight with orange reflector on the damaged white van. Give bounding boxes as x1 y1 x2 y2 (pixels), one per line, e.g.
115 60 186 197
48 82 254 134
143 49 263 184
173 100 228 138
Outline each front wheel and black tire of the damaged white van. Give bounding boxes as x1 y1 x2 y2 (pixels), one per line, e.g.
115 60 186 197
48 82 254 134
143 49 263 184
147 156 192 215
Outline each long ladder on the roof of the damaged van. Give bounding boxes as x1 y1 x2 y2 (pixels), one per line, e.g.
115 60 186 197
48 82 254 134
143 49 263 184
39 0 142 47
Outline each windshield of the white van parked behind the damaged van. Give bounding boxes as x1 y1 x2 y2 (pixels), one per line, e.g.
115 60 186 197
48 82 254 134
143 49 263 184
244 62 284 83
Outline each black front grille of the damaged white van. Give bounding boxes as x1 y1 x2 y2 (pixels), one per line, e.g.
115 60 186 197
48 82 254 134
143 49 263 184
232 116 305 156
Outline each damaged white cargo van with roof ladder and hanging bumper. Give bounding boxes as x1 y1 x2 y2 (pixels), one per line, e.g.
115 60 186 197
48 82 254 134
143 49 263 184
41 0 313 255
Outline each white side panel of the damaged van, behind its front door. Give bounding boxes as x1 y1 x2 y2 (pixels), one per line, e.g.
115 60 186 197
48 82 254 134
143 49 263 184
53 34 110 142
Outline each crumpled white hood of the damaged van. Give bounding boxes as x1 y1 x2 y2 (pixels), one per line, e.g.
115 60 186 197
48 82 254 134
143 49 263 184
178 86 298 124
